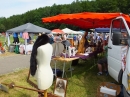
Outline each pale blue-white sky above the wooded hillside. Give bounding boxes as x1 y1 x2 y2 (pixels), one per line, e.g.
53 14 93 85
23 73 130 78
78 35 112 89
0 0 74 18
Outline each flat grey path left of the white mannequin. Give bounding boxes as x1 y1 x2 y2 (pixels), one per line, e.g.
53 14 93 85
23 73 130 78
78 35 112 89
0 54 30 75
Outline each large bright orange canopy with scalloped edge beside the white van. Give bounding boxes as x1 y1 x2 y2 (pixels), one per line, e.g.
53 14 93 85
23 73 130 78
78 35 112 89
42 12 130 29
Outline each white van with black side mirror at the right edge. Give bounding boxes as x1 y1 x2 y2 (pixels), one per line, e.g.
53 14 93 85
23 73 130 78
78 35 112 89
108 16 130 97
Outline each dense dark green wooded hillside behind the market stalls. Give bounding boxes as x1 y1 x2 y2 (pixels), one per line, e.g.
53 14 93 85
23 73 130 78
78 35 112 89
0 0 130 32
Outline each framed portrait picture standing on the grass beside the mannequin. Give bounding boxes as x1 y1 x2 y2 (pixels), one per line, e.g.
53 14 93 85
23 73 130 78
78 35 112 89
54 77 68 97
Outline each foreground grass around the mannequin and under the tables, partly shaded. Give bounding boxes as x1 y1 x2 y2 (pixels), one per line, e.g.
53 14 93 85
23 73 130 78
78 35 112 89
0 58 115 97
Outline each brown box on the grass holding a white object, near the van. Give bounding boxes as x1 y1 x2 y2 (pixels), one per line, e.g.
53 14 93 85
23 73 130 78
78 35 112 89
97 82 121 97
